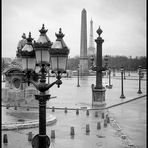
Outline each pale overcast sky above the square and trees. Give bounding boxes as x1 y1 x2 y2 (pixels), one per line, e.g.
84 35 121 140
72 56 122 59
2 0 146 57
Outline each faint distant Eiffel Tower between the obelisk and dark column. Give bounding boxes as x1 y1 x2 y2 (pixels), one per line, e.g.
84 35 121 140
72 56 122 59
87 19 95 56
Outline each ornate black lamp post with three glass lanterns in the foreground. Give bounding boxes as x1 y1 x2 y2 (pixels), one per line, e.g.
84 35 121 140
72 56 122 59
21 24 69 148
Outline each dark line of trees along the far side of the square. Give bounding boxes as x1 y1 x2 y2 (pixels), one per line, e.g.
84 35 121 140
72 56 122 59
67 56 147 71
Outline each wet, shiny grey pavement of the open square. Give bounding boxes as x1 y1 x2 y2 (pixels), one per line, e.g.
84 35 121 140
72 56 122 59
2 74 147 148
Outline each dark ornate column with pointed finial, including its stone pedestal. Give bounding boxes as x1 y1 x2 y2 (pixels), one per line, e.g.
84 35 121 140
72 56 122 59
91 26 106 107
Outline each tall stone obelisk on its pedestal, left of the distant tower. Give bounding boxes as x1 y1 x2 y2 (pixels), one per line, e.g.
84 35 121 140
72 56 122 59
80 9 88 76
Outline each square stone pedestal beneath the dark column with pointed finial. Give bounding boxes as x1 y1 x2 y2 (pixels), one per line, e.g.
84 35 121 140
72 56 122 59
92 84 106 107
